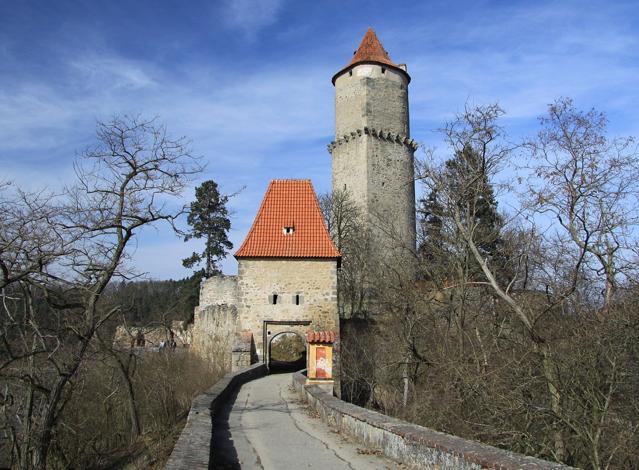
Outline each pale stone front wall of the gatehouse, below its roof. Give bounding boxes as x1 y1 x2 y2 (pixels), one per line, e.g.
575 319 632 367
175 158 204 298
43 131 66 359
238 259 339 360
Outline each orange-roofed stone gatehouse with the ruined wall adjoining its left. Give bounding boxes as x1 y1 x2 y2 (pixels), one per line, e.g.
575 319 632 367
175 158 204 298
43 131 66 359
193 180 340 390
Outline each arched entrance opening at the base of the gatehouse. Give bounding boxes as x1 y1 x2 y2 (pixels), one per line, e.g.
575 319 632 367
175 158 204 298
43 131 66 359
262 320 311 371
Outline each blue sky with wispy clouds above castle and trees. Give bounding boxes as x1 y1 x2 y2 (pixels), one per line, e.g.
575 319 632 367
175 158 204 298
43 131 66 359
0 0 639 278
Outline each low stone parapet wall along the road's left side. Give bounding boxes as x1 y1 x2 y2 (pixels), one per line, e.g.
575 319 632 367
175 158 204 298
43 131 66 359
164 364 266 470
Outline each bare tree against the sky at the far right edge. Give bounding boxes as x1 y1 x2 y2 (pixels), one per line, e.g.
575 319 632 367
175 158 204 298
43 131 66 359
528 98 639 308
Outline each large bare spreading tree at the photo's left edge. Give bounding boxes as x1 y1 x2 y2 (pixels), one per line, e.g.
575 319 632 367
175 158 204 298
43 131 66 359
0 116 200 468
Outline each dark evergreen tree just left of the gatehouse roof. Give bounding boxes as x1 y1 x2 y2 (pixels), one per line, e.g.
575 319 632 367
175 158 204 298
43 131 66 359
182 180 233 277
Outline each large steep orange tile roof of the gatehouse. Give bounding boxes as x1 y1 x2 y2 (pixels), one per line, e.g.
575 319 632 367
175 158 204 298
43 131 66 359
235 180 340 259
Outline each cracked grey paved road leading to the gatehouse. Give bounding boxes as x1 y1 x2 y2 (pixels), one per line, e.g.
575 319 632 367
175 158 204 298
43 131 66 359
213 374 399 470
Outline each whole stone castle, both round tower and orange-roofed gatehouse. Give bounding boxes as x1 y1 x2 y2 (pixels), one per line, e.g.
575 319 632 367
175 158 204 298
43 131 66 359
193 29 417 382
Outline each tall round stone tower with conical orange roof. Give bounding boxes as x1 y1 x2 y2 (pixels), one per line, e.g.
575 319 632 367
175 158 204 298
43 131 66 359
329 28 417 269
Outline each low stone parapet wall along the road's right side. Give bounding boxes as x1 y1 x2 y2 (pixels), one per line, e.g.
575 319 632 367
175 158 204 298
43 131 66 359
293 372 572 470
